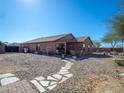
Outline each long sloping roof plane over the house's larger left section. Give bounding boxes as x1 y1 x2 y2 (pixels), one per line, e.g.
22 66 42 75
24 33 70 43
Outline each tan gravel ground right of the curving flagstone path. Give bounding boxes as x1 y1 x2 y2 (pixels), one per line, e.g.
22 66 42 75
50 56 118 93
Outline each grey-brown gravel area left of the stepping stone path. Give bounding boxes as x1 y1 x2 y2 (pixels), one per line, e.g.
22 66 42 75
0 53 64 80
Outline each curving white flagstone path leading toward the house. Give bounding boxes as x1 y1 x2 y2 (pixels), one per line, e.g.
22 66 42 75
30 60 73 93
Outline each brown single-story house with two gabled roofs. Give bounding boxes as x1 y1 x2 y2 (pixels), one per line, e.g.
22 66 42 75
20 33 93 55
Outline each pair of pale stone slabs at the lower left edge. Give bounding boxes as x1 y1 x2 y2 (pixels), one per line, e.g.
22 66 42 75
0 73 19 86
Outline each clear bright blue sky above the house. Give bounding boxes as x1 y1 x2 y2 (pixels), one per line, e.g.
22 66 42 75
0 0 119 42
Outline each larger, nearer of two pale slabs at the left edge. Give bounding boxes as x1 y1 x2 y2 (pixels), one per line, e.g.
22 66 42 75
1 77 19 86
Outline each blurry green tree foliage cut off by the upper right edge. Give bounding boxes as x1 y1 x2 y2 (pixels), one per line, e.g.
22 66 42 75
110 1 124 51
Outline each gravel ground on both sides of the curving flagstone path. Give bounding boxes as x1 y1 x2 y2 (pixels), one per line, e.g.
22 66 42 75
0 53 124 93
